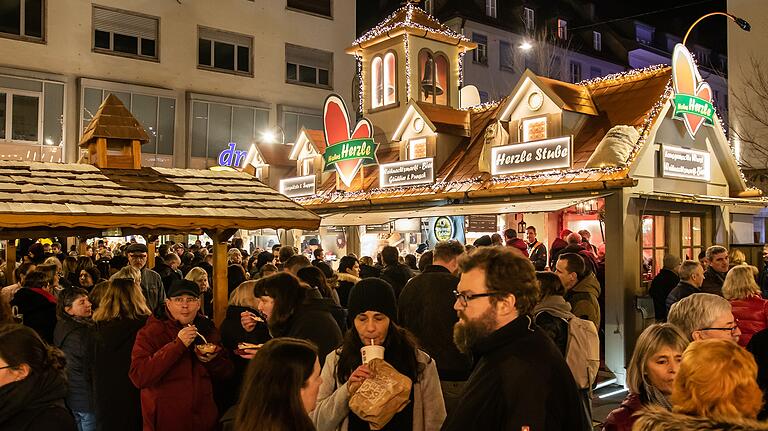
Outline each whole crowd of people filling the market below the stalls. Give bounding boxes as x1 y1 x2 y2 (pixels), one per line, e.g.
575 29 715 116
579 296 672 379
0 233 768 431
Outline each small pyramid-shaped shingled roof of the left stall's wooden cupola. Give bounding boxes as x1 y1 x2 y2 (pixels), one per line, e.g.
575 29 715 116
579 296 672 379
80 93 149 147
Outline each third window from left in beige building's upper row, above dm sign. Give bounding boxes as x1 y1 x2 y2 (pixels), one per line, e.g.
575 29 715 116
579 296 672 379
197 27 253 76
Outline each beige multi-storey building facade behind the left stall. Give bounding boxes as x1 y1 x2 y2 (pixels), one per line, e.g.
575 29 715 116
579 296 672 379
0 0 355 172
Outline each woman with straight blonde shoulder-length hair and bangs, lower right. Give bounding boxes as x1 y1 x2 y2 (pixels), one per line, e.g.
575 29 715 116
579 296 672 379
603 323 688 431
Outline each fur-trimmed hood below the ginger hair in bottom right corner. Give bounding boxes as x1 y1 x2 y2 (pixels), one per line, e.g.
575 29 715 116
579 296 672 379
632 408 768 431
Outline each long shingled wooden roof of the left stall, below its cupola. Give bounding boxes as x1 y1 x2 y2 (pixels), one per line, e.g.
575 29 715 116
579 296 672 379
0 161 320 238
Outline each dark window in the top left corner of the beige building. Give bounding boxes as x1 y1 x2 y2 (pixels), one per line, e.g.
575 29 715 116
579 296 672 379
0 0 45 40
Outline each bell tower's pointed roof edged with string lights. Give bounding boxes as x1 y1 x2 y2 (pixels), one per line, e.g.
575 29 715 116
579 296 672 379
347 0 477 54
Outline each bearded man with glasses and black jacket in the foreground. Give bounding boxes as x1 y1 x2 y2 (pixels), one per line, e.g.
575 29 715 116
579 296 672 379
442 247 591 431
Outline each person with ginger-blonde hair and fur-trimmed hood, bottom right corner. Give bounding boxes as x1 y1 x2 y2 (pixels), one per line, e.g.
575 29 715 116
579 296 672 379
634 339 768 431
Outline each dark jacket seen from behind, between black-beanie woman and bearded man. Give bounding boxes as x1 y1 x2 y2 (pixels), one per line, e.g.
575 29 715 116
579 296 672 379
397 265 472 381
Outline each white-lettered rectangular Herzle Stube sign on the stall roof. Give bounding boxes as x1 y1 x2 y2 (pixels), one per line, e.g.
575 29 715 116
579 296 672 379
491 136 572 175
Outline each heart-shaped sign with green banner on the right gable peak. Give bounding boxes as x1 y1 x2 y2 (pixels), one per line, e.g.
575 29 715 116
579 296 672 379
672 43 715 139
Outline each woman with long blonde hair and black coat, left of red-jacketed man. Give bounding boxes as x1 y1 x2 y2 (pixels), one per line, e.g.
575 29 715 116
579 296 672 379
92 278 152 431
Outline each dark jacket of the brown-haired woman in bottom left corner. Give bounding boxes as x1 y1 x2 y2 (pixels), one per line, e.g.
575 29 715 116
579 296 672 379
0 370 77 431
